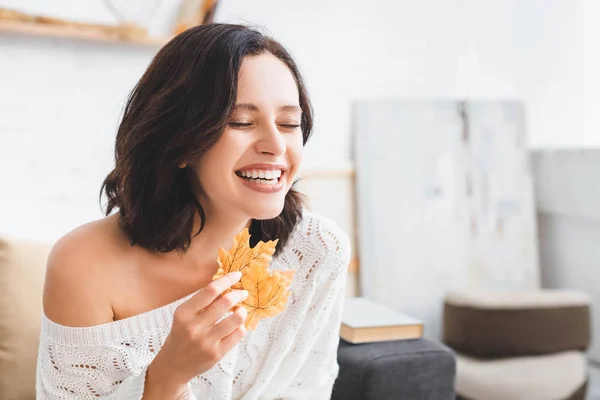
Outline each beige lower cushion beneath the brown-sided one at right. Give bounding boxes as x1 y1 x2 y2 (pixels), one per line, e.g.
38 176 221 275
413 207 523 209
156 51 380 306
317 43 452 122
456 351 587 400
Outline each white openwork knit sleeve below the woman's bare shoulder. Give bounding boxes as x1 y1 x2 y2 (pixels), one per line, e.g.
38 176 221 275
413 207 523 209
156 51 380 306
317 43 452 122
36 316 202 400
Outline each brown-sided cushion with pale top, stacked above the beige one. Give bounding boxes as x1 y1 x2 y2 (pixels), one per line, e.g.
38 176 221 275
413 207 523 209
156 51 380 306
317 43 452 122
443 290 591 358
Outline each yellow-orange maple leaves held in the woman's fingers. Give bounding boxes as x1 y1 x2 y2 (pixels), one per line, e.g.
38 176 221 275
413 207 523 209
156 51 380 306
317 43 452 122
213 228 295 330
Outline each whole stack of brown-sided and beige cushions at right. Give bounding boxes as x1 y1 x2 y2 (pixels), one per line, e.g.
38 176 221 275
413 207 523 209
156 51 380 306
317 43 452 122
443 290 591 400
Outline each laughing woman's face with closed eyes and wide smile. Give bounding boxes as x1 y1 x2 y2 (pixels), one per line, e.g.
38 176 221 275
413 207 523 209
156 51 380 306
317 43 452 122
191 53 304 219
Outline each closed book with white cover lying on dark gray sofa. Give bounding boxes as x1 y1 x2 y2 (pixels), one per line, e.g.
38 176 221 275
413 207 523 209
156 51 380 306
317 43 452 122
340 297 424 343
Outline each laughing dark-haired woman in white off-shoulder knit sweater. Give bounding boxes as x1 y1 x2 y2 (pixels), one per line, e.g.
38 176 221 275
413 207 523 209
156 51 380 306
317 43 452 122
37 24 349 400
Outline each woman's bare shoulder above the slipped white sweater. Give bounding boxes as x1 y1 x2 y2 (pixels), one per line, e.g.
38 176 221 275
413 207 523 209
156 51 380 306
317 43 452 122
43 216 124 327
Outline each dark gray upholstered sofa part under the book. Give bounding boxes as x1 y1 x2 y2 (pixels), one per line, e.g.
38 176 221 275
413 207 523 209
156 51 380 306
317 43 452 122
331 338 456 400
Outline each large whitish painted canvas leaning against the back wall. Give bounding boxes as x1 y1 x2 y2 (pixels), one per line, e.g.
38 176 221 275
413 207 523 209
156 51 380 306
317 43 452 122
353 101 539 338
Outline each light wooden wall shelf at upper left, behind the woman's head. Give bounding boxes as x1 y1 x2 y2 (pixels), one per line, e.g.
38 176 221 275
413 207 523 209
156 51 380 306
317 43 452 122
0 20 169 47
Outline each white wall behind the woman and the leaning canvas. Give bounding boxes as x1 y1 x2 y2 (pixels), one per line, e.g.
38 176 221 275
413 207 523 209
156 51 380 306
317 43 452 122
0 0 600 239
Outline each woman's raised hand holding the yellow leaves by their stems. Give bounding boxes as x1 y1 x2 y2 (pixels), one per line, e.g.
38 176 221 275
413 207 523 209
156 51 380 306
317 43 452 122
144 272 248 400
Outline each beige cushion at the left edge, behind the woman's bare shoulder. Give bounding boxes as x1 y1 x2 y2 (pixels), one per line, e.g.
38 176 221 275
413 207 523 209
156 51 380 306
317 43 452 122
0 238 50 400
